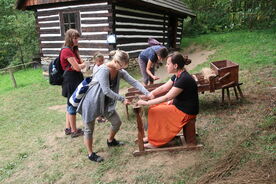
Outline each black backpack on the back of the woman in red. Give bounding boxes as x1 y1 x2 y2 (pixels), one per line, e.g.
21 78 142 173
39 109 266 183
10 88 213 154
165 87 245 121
49 47 68 85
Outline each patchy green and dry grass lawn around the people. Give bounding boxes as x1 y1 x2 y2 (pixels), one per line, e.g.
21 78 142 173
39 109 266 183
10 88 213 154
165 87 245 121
0 30 276 184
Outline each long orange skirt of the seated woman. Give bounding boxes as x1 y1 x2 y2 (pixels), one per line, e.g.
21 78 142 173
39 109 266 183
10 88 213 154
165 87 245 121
148 102 196 147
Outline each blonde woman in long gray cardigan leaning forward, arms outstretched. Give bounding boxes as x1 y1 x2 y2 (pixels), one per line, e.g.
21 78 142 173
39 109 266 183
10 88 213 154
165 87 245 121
77 50 150 162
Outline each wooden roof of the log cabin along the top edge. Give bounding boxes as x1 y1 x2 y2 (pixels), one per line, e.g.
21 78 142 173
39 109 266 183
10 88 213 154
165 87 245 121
16 0 196 16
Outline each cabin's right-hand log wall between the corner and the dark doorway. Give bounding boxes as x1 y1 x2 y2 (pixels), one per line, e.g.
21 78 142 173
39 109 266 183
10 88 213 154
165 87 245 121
114 5 168 57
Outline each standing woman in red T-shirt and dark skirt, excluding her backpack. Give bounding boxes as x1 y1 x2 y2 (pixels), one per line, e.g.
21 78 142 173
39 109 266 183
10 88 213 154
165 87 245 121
60 29 85 138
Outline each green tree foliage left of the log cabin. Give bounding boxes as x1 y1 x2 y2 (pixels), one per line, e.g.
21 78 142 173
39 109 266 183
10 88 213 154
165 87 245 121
0 0 39 68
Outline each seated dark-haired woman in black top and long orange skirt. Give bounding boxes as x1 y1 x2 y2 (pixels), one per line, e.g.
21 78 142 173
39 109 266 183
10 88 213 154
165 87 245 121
138 52 199 148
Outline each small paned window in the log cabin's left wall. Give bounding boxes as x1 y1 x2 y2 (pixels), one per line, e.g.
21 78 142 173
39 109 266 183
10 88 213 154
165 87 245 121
60 12 80 35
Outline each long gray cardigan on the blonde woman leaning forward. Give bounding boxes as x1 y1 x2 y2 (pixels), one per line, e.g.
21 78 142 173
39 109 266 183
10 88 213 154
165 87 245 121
77 64 149 123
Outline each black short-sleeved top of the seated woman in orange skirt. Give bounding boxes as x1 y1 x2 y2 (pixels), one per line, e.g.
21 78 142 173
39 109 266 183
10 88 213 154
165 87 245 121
171 71 199 115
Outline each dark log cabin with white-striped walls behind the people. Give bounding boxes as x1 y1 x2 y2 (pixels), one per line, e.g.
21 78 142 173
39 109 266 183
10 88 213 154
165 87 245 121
16 0 196 69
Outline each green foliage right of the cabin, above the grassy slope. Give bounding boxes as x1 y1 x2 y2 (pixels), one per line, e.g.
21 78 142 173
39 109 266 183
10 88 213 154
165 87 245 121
183 0 276 34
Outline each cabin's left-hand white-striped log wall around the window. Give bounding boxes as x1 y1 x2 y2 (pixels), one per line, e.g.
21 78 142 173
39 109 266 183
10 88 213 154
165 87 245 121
36 1 112 61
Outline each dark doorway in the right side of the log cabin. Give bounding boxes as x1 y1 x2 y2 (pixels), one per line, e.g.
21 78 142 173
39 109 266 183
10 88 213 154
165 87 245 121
168 15 177 50
